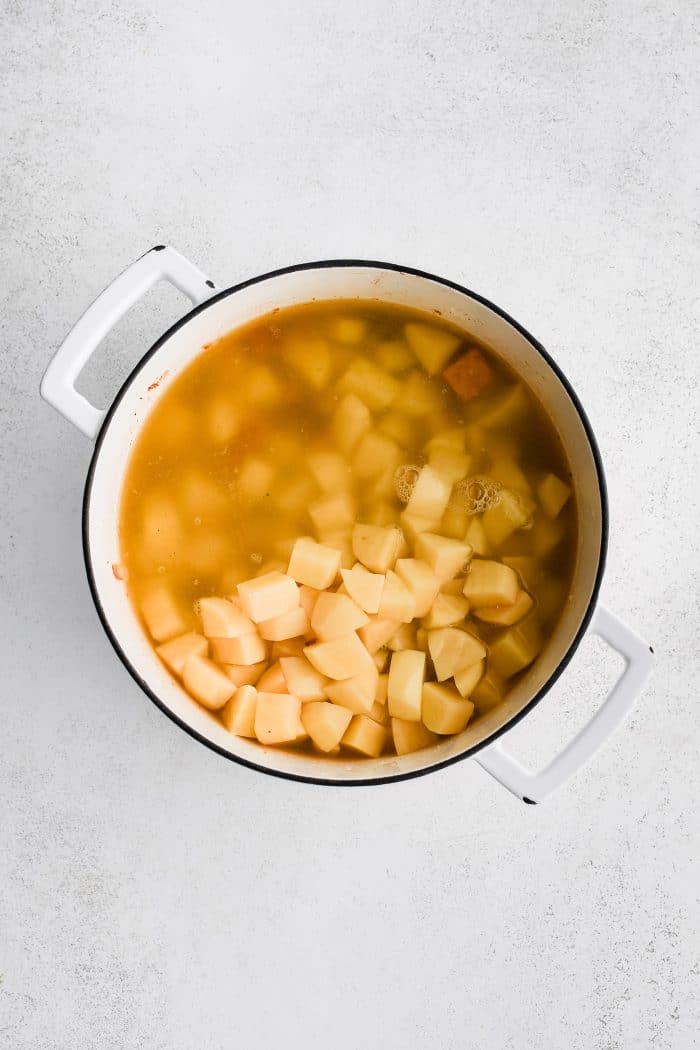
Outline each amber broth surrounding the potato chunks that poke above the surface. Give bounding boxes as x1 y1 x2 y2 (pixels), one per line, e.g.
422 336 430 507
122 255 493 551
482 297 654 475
120 301 576 757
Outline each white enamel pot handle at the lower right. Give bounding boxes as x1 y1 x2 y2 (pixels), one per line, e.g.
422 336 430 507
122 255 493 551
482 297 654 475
475 606 654 803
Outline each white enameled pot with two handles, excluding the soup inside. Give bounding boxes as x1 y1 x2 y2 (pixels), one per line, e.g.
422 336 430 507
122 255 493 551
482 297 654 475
41 246 653 802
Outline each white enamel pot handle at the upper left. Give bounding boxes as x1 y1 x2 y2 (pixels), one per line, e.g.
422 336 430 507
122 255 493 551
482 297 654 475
41 245 216 440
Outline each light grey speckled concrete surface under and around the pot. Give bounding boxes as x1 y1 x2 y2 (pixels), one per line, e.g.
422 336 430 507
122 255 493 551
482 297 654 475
0 0 700 1050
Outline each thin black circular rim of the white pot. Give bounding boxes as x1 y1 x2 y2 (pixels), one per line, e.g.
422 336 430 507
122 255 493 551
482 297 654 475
82 258 609 788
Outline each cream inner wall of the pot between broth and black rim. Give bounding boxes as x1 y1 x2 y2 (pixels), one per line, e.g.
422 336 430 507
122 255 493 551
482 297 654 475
84 264 603 782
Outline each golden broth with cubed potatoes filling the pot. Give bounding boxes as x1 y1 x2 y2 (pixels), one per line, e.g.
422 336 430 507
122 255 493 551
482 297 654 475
116 300 576 758
